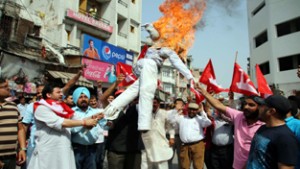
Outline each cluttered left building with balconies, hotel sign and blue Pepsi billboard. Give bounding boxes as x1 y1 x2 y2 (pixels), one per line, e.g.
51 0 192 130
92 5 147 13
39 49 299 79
0 0 142 91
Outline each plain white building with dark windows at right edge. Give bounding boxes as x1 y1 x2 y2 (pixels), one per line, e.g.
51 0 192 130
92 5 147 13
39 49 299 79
247 0 300 96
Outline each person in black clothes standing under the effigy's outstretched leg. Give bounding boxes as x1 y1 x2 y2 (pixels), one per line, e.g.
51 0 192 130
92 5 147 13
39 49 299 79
107 91 141 169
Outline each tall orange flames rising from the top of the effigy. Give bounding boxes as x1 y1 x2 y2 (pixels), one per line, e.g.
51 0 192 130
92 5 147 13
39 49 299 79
153 0 206 61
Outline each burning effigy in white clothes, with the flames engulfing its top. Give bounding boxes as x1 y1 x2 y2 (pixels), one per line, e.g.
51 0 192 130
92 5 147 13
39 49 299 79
104 0 205 162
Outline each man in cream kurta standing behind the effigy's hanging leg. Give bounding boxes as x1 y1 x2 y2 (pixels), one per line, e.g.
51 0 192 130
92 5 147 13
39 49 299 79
139 97 175 169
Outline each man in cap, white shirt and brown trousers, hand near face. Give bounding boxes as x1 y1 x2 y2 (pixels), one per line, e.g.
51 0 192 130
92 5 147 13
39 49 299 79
175 102 211 169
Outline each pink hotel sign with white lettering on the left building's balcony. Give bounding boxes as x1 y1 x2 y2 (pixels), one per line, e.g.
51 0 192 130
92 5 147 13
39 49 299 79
67 9 113 33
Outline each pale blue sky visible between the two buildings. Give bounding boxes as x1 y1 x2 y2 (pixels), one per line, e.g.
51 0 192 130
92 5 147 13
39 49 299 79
142 0 250 87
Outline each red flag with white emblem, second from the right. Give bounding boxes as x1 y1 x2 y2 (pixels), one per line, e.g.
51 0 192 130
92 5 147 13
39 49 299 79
230 63 258 96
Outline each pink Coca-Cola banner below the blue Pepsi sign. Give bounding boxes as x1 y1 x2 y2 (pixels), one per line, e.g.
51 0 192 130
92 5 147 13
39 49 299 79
81 58 114 82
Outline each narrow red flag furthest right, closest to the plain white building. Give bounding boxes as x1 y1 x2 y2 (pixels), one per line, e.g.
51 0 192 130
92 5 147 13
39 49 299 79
255 64 273 97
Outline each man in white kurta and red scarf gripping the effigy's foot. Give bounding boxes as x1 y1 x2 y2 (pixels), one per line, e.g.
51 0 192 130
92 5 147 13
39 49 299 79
28 84 98 169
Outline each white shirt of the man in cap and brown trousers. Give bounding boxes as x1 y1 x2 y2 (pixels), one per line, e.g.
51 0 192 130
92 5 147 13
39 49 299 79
176 112 211 143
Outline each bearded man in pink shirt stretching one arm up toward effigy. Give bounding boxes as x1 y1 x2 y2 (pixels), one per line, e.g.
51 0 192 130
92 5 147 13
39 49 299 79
196 84 263 169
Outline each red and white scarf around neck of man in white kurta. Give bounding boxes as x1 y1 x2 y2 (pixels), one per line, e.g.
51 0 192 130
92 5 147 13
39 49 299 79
33 99 74 119
